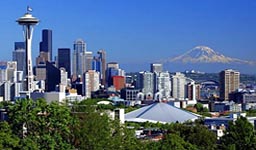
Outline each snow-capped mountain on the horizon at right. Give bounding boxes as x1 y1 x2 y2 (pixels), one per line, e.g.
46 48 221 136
164 46 255 65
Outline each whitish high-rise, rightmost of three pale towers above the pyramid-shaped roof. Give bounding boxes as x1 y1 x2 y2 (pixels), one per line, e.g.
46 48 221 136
171 72 186 100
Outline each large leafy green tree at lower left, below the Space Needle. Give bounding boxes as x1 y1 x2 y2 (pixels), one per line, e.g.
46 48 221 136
8 99 73 149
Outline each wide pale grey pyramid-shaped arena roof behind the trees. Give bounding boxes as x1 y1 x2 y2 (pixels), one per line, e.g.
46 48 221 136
125 102 200 123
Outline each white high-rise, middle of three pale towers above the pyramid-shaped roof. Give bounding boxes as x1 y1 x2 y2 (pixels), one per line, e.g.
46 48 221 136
157 72 171 98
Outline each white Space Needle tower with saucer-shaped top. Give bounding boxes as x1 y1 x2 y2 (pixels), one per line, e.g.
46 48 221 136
16 7 39 98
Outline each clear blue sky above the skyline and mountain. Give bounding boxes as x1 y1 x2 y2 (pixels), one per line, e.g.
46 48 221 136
0 0 256 71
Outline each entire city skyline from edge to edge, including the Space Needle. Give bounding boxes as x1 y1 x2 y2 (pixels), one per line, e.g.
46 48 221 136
0 11 256 111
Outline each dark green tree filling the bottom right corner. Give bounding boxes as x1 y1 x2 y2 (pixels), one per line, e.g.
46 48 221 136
221 117 256 150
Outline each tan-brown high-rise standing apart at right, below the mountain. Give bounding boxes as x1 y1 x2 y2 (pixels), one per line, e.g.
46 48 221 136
219 69 240 100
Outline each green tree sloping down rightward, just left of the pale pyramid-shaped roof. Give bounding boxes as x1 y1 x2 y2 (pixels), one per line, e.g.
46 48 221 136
71 102 141 150
